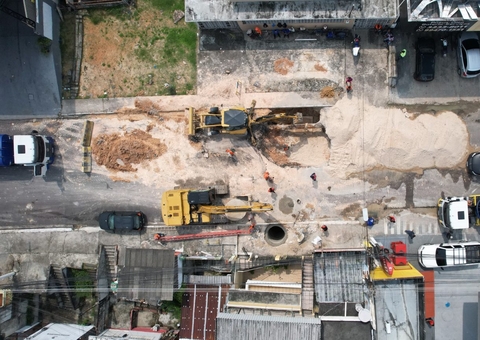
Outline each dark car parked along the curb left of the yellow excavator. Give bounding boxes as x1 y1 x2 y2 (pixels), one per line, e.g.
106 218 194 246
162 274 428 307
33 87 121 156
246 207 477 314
98 211 146 232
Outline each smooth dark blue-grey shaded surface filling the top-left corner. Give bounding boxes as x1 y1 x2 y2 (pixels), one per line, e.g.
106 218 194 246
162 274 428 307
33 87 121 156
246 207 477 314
0 1 61 119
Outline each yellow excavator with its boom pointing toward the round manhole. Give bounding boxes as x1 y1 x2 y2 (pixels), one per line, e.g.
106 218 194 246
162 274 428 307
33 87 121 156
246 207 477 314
162 188 273 226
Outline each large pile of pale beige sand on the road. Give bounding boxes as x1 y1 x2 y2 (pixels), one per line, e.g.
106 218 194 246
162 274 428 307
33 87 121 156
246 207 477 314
317 99 468 176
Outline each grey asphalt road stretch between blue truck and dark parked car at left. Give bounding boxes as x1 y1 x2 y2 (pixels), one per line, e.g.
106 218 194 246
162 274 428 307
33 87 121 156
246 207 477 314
0 163 160 227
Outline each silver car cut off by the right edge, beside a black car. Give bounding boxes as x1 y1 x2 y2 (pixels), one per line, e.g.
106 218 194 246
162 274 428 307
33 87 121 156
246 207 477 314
457 32 480 78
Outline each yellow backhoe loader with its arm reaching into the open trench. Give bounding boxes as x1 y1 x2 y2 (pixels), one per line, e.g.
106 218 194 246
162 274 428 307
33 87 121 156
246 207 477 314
188 100 302 145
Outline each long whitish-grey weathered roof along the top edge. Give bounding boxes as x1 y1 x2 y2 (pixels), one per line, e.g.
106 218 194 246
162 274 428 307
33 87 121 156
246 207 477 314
185 0 397 23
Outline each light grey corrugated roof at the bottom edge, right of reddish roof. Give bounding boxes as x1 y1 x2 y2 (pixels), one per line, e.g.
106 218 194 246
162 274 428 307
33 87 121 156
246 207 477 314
217 313 322 340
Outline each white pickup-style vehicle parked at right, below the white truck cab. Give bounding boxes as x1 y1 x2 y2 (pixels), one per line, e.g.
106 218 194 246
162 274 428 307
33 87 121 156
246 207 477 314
418 242 480 268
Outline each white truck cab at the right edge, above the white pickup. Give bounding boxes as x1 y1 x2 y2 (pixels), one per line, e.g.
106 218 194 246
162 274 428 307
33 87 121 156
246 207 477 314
437 195 480 230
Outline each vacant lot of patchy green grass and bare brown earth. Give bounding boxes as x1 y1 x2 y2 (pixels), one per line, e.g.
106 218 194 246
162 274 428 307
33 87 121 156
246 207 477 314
79 1 195 98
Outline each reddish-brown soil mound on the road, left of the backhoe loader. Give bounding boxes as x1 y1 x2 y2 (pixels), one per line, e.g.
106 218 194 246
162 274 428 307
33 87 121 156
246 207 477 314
92 129 167 171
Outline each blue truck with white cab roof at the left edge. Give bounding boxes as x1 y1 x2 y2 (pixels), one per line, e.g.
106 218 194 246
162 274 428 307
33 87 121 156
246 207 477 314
0 131 55 176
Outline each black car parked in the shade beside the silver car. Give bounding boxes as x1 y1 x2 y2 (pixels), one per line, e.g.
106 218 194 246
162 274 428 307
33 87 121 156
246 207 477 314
413 38 435 81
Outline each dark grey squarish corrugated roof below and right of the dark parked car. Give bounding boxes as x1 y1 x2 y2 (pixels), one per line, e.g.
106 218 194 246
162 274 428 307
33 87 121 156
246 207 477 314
117 248 175 305
